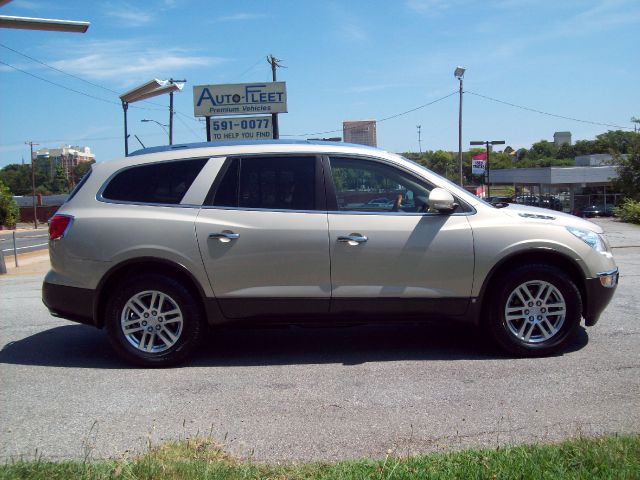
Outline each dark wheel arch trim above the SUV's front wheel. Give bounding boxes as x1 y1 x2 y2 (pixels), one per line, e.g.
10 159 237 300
478 248 587 324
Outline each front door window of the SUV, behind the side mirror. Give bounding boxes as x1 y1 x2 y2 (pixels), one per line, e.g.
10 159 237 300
330 157 432 212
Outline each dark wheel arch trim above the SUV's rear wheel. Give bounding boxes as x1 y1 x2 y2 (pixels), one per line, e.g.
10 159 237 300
93 257 221 328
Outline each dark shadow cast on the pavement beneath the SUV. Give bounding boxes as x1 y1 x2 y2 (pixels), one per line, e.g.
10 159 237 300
0 325 589 369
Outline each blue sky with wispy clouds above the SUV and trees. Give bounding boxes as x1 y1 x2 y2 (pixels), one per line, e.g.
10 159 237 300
0 0 640 167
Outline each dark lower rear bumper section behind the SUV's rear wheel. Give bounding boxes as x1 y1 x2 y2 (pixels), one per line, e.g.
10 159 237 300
42 282 96 326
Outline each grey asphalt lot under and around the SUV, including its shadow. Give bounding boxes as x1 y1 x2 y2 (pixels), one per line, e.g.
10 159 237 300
0 220 640 461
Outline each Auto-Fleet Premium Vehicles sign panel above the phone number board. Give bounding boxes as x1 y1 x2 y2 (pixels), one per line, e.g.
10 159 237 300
193 82 287 117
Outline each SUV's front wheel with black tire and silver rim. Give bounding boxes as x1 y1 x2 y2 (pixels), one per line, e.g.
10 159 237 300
487 264 582 357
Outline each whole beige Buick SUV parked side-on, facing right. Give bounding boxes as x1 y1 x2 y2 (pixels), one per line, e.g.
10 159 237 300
43 141 618 365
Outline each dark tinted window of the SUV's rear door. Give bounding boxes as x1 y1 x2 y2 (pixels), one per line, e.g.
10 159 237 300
213 157 316 210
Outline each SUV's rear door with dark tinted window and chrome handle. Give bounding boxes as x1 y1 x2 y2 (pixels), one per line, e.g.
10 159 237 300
196 155 331 318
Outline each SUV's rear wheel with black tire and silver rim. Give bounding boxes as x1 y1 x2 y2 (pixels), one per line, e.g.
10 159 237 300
105 274 206 367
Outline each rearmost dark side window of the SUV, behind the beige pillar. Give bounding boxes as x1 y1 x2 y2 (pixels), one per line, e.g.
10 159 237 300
102 158 207 205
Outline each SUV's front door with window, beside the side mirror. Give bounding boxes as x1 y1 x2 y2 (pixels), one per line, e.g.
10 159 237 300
327 157 474 315
